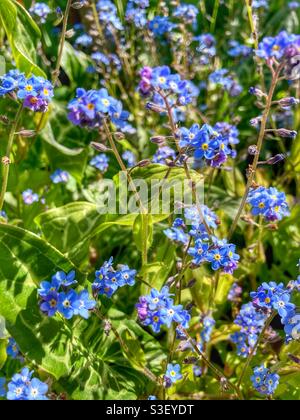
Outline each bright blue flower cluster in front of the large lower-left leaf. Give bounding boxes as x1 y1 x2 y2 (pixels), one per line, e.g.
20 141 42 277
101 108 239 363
38 271 96 319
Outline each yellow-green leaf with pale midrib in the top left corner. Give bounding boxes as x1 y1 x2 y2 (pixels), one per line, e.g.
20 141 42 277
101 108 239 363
0 0 45 77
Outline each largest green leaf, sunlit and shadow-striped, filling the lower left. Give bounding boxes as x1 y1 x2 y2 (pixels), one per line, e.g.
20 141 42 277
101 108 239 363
0 224 155 399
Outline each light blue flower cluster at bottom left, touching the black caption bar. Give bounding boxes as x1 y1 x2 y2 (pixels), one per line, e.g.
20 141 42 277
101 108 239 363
6 368 48 401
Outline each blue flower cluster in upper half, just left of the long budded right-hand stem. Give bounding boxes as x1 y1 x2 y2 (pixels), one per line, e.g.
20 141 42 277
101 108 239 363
179 123 239 167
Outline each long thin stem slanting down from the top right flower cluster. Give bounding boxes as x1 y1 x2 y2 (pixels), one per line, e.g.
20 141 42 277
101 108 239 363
229 66 282 239
